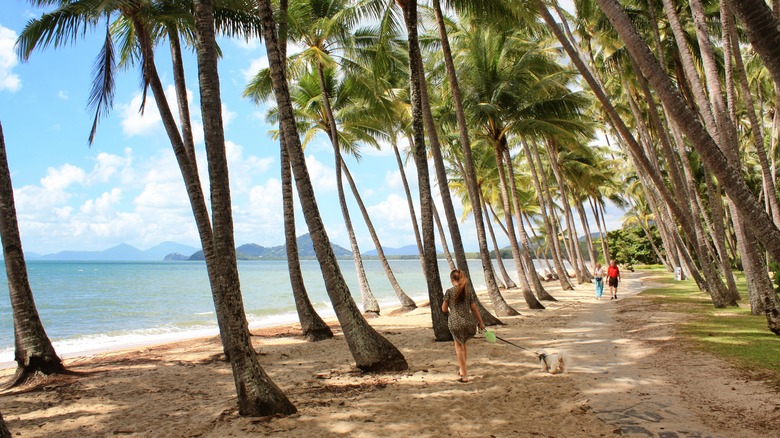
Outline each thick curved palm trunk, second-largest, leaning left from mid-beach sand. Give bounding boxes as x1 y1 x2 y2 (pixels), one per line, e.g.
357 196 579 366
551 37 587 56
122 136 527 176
257 0 409 362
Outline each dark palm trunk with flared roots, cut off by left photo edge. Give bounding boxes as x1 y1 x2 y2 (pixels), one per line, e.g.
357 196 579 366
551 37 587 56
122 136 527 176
0 124 64 384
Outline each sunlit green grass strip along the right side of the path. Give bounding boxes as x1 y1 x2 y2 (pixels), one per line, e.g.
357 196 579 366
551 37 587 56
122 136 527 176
640 274 780 387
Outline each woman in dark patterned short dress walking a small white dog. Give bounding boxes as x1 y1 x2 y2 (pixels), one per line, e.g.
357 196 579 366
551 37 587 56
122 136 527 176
441 269 485 383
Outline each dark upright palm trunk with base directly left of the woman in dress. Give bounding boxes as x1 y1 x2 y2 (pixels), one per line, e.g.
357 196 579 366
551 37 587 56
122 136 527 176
399 0 450 341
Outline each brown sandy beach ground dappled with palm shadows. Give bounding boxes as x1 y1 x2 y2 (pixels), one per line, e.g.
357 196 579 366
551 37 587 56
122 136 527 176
0 273 780 437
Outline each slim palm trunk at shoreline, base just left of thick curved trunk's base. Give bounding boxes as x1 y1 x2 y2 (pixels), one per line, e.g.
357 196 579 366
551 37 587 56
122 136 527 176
279 0 333 342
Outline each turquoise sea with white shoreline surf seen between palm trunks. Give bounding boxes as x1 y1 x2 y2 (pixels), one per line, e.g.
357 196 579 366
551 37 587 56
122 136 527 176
0 259 514 368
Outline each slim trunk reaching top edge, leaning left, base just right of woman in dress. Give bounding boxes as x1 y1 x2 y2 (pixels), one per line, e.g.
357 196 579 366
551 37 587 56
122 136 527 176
426 0 503 325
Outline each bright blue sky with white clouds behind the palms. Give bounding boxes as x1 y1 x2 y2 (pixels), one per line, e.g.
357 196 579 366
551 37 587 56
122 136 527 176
0 1 622 254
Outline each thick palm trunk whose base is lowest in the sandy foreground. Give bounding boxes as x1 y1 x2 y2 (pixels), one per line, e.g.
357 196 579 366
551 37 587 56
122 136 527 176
194 0 296 416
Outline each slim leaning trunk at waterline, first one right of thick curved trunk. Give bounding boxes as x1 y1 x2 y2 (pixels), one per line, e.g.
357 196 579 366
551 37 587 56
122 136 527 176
317 62 379 316
